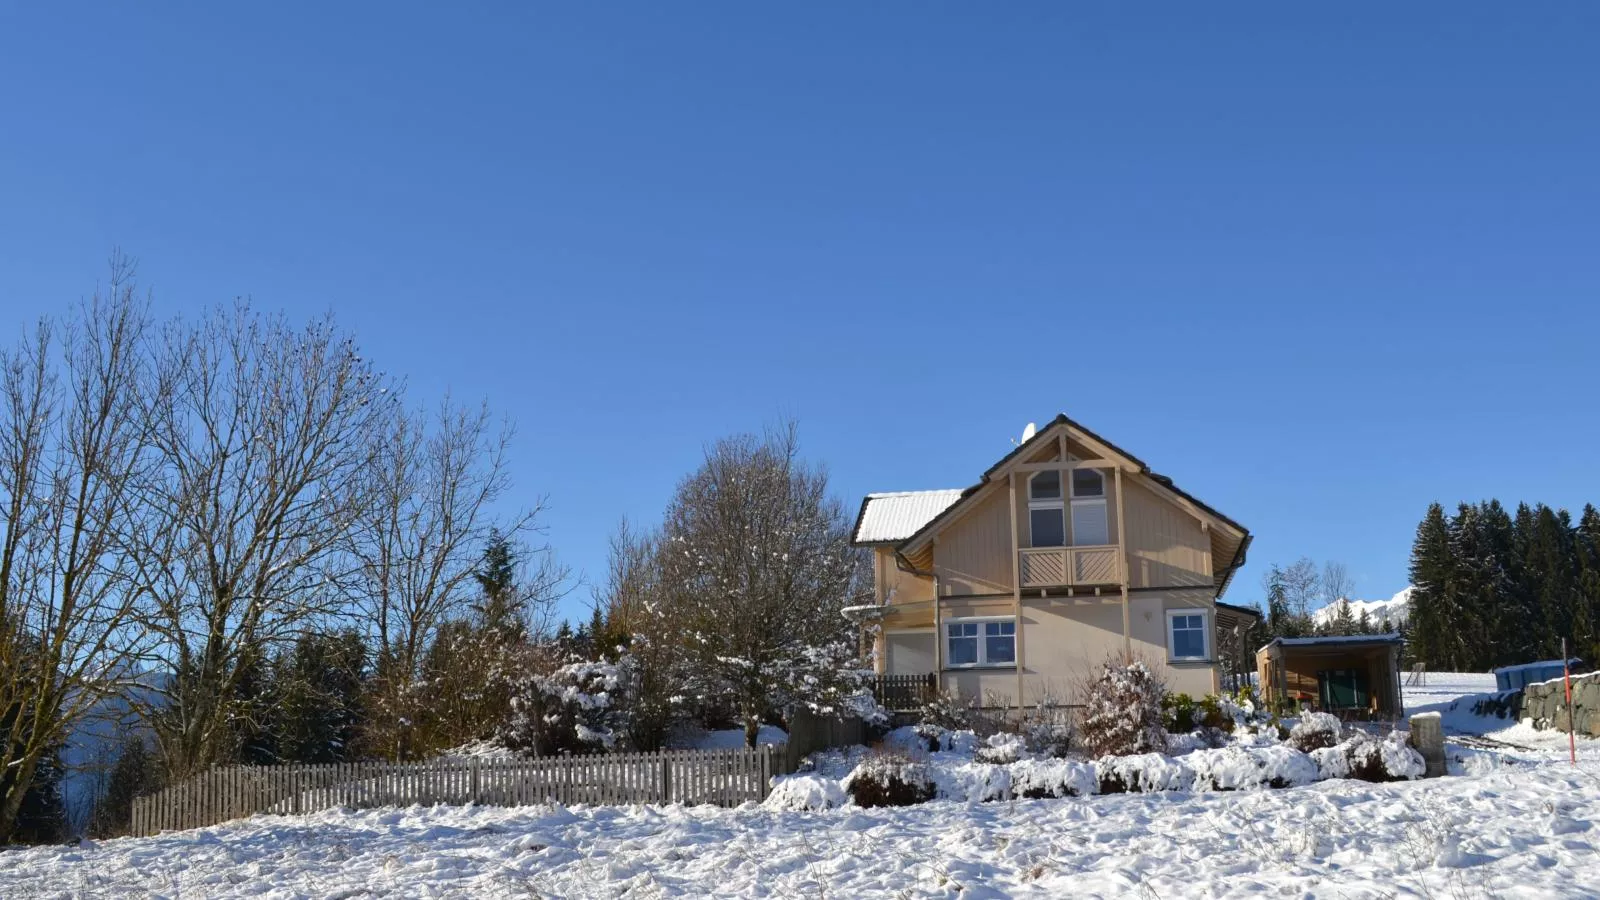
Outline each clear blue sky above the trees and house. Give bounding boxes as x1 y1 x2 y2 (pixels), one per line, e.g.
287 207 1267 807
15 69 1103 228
0 3 1600 615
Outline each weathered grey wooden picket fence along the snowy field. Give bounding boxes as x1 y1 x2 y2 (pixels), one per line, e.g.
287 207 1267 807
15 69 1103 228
131 745 786 836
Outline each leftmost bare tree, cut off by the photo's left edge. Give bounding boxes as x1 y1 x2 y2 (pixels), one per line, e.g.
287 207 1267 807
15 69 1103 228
0 255 146 842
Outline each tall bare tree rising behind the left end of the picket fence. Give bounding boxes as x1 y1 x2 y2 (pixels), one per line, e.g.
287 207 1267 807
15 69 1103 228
134 303 395 775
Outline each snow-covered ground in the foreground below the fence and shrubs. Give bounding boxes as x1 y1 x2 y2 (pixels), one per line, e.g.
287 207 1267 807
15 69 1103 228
0 674 1600 900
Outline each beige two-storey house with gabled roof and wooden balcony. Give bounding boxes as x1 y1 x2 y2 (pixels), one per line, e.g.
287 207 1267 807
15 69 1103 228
851 415 1254 706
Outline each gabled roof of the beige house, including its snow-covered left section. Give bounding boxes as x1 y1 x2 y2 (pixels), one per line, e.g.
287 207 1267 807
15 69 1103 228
854 413 1254 597
